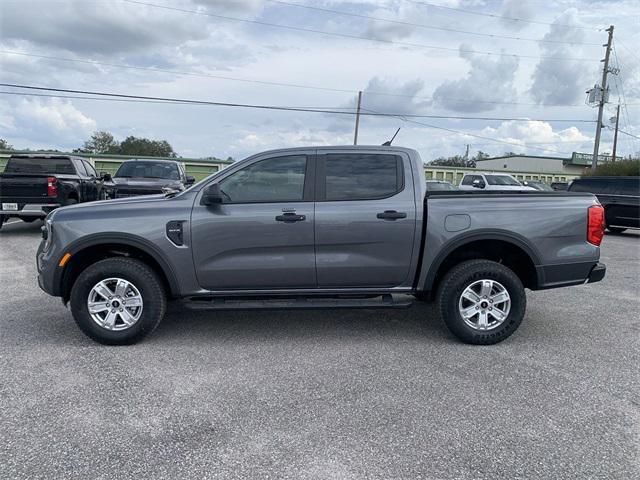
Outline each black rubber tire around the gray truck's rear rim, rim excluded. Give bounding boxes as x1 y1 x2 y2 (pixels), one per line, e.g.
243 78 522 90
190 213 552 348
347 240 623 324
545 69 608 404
437 260 527 345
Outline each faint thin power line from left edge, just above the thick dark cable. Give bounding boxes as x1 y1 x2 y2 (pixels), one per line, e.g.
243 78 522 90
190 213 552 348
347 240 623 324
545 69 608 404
0 50 592 108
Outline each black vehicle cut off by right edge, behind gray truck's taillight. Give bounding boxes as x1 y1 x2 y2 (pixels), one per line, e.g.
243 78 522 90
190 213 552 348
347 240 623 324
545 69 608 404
569 177 640 233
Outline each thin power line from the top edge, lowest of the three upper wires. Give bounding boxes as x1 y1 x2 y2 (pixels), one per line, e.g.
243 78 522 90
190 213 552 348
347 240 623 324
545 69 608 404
122 0 595 62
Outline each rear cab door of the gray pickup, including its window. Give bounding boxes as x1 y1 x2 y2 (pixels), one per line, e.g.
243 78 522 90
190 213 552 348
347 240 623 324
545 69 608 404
316 150 417 288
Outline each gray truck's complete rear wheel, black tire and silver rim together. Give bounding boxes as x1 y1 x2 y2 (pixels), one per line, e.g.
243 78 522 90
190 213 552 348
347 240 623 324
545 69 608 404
438 260 527 345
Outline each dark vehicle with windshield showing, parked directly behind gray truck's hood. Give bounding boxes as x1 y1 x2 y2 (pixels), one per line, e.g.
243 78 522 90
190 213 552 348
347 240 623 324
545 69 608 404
113 160 195 198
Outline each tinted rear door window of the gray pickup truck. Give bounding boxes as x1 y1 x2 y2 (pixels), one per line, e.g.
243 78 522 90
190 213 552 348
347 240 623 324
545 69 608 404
319 153 404 201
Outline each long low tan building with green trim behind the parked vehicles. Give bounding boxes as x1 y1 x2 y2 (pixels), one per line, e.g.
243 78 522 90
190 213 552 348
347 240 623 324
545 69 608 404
0 156 579 185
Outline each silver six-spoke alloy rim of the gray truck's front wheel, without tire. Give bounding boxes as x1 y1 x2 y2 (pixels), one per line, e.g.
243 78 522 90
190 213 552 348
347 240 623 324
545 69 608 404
87 278 143 331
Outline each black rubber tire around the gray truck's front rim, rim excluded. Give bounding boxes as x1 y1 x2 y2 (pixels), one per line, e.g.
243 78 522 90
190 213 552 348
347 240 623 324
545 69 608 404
70 257 167 345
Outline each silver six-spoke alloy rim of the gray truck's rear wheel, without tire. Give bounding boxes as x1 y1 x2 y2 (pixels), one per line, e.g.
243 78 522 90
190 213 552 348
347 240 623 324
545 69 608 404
458 280 511 330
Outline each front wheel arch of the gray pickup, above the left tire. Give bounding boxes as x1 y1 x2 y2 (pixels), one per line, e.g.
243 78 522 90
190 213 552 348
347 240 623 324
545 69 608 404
55 232 180 303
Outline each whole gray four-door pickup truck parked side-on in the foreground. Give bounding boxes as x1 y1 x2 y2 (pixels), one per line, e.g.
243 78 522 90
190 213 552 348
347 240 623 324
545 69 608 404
37 146 605 344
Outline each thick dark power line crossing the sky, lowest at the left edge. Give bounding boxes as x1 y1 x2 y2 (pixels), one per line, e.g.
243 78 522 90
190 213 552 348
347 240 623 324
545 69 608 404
0 83 594 123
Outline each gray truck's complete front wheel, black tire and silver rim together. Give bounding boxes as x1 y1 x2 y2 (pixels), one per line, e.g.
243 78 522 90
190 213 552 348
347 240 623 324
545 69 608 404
71 257 166 345
